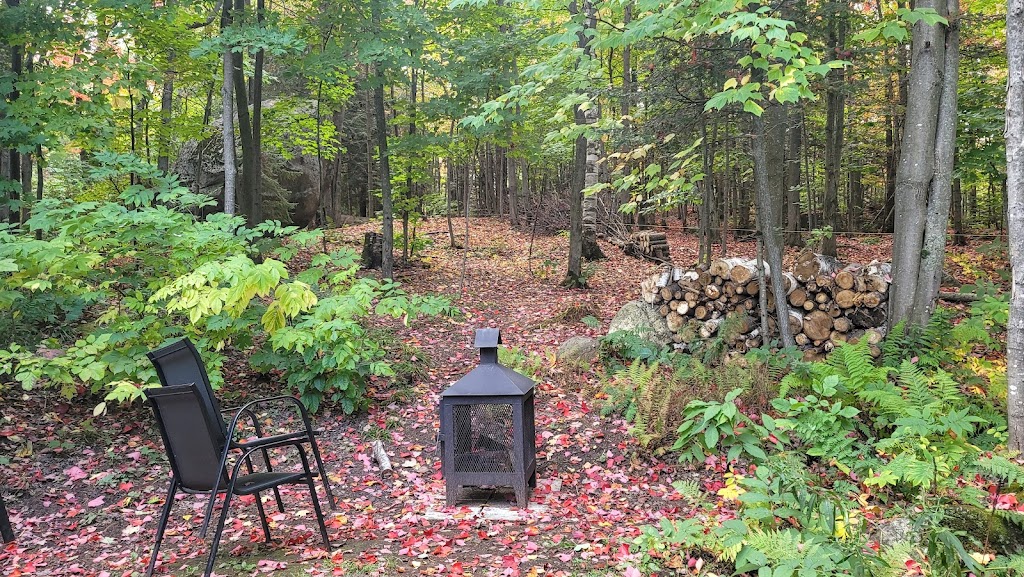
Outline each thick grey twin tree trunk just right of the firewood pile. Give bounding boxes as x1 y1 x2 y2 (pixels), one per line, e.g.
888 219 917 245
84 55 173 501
889 0 959 328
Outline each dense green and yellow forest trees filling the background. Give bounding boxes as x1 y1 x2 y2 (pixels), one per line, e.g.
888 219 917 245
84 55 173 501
0 0 1007 253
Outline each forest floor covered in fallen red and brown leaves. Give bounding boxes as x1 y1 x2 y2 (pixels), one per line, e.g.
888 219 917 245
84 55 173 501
0 218 999 576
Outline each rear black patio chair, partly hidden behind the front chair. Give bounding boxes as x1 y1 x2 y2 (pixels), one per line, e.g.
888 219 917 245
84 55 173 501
146 338 337 537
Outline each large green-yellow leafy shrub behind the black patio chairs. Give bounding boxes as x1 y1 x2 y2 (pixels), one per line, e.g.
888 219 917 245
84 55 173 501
0 157 451 411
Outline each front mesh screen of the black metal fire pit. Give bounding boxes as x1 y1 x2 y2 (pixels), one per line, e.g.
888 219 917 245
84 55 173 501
452 405 515 472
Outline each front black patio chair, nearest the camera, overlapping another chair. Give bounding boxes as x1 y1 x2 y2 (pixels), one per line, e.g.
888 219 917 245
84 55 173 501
144 383 331 577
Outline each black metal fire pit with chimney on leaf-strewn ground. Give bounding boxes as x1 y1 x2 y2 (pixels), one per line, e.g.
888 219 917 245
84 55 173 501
439 329 537 507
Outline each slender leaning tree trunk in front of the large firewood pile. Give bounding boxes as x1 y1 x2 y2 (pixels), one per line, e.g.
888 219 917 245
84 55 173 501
753 105 796 346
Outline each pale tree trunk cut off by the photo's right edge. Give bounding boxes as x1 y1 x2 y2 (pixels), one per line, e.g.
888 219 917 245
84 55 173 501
1006 0 1024 451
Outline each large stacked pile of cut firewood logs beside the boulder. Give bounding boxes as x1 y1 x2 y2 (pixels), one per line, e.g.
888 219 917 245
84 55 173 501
640 251 890 358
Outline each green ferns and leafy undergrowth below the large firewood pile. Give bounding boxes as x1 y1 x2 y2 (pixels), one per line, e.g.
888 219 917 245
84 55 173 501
602 305 1024 576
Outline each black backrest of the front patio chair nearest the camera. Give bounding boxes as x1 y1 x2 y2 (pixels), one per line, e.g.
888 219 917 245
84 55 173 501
142 383 227 492
